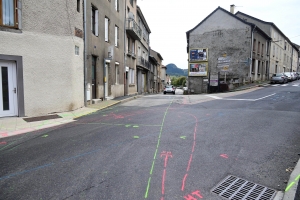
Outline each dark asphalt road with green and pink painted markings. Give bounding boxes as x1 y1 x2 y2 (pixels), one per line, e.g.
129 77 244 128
0 81 300 200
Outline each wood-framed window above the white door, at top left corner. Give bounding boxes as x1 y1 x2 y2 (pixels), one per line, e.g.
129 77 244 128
0 0 18 28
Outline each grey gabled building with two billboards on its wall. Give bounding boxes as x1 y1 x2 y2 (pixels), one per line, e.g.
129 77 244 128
186 7 271 93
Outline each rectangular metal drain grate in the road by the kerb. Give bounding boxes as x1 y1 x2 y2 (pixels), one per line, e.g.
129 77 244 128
211 175 276 200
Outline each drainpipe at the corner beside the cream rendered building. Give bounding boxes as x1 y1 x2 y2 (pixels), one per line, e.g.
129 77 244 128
83 0 87 107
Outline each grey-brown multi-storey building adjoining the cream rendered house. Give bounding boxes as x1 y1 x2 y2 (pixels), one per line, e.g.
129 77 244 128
85 0 125 103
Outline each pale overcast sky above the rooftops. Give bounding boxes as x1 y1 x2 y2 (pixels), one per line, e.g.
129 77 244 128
137 0 300 69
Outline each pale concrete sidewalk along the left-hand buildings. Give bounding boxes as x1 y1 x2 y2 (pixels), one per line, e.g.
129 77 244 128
0 95 142 139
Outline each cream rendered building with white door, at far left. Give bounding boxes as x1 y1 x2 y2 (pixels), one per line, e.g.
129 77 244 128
0 0 84 117
